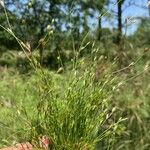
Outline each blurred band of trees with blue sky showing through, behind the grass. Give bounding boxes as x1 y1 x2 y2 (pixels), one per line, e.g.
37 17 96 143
0 0 150 69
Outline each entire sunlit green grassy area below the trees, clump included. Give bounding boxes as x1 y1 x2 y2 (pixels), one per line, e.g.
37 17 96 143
0 47 150 150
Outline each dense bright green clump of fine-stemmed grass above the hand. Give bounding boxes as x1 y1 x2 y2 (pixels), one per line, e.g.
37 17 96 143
30 68 121 149
